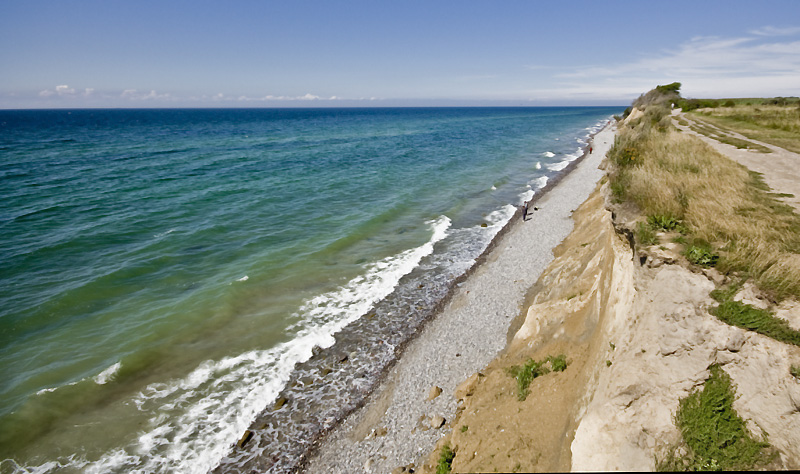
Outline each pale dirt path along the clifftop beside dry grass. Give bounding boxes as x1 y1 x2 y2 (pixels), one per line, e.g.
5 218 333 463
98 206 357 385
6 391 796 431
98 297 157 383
673 109 800 211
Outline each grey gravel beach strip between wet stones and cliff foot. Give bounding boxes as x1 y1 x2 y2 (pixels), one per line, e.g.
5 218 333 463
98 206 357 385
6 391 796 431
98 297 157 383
305 121 616 473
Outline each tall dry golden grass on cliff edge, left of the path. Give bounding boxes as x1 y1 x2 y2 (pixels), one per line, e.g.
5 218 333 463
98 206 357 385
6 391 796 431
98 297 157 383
609 110 800 298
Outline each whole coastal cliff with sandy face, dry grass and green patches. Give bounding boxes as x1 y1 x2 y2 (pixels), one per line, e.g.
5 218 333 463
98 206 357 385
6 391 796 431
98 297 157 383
419 88 800 473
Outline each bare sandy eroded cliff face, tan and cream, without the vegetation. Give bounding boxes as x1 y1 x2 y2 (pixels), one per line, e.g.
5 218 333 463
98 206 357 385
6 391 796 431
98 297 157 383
423 180 800 472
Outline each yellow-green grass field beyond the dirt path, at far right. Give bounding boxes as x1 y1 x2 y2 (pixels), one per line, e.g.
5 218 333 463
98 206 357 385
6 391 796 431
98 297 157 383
691 104 800 153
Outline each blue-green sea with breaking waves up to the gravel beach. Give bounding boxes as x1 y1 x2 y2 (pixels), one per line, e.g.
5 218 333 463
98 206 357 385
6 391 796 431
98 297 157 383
0 107 622 474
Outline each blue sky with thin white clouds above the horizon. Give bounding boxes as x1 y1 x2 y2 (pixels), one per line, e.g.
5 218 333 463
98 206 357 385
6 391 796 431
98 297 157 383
0 0 800 109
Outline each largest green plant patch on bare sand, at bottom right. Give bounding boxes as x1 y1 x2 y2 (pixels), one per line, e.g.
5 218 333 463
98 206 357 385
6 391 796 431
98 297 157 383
656 365 777 471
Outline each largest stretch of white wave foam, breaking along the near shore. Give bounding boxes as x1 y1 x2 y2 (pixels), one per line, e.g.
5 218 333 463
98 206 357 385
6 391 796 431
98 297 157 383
21 216 454 473
